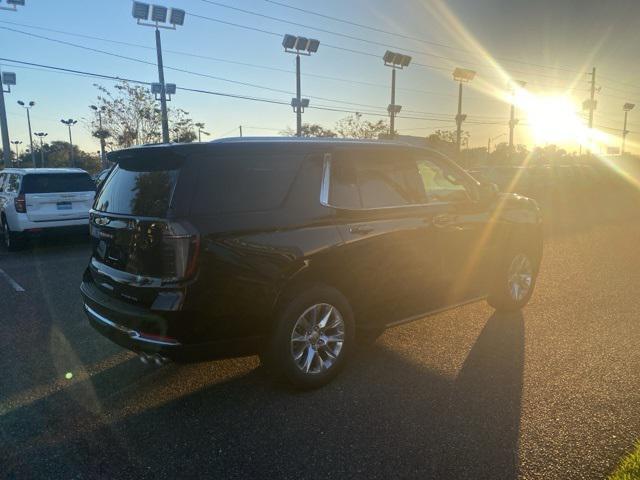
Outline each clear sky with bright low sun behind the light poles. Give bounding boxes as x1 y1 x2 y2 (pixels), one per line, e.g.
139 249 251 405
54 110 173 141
0 0 640 153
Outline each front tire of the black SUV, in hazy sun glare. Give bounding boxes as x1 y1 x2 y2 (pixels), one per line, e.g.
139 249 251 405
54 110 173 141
487 246 540 312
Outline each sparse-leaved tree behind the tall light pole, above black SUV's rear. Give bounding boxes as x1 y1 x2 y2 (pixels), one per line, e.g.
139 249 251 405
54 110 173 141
89 81 197 149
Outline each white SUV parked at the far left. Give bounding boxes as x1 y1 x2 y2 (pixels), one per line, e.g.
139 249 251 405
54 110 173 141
0 168 96 250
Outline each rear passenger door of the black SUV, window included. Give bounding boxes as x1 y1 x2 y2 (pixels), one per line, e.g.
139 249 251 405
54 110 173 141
328 149 441 324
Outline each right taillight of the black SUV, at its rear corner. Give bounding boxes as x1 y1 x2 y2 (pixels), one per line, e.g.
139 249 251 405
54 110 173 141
162 223 200 281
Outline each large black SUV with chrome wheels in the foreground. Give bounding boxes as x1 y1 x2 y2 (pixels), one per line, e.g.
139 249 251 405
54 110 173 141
81 138 542 388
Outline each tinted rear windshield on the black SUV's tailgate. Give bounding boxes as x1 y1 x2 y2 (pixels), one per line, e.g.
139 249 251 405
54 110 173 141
94 162 179 217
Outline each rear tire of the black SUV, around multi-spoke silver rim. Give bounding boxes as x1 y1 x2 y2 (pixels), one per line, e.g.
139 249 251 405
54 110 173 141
260 285 355 390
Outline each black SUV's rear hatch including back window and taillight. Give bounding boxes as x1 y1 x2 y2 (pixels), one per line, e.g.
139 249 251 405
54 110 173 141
90 155 199 305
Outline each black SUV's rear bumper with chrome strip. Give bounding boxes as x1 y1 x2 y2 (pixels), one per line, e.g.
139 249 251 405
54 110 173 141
80 281 262 362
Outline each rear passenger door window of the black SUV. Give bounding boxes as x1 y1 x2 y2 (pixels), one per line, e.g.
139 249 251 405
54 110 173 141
329 150 426 208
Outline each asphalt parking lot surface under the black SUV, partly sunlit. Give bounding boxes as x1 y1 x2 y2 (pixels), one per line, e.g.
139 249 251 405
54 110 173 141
0 192 640 479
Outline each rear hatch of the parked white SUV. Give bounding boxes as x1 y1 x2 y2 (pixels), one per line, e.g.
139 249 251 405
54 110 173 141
21 172 96 222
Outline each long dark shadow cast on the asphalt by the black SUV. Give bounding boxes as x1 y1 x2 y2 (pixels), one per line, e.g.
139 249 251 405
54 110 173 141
0 314 524 479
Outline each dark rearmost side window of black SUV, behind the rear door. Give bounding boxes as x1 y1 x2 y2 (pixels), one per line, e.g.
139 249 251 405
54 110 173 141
192 153 304 215
